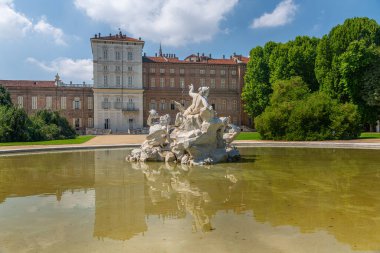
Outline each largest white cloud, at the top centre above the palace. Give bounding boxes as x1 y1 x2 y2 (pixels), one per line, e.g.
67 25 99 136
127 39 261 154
75 0 238 46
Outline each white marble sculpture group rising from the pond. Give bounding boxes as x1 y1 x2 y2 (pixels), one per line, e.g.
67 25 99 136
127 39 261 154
126 85 240 165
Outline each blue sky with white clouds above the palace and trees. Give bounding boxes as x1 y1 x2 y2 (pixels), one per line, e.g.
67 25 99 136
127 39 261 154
0 0 380 83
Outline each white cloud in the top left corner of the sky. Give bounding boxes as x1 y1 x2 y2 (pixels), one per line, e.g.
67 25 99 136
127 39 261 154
0 0 66 45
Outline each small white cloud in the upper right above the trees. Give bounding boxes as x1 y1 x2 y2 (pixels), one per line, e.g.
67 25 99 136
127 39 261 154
251 0 298 28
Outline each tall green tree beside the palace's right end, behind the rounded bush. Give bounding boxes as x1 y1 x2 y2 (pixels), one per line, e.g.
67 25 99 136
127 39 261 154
242 36 319 120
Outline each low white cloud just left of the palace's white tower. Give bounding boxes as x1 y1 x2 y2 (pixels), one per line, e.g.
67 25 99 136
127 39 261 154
27 57 92 83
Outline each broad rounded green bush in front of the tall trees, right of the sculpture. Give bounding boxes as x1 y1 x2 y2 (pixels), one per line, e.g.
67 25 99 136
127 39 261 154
255 77 361 141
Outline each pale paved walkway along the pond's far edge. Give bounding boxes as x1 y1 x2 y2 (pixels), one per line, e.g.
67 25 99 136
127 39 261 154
0 135 380 154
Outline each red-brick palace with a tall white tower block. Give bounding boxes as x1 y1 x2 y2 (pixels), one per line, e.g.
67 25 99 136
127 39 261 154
0 32 252 133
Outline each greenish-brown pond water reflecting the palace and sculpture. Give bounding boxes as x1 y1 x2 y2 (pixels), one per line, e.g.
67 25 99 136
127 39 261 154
0 148 380 253
